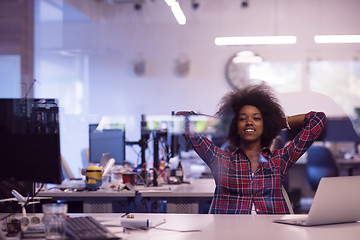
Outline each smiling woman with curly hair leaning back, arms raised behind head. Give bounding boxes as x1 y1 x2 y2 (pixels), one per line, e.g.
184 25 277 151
178 85 326 214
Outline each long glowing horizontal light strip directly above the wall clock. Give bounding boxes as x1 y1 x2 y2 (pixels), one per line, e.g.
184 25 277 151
215 36 296 46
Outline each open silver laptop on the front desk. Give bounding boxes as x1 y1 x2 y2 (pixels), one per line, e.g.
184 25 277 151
274 176 360 226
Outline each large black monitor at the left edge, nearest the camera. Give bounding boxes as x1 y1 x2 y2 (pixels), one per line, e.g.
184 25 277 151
0 98 62 183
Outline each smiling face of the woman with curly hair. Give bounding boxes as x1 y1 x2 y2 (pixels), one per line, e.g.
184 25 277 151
237 105 264 144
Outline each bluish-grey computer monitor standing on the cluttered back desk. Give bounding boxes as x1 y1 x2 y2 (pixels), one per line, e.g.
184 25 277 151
89 124 126 164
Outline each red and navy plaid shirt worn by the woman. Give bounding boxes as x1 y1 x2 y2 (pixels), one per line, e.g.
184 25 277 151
182 112 326 214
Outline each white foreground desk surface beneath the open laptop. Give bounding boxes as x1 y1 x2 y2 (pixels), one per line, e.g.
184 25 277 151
0 213 360 240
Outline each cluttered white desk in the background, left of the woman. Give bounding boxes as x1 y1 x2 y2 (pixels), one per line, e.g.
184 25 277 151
38 179 215 213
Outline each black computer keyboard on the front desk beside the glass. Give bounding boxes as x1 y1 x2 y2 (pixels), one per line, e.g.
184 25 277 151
65 216 121 240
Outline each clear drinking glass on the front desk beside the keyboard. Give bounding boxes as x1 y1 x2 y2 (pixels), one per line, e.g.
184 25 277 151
42 203 67 240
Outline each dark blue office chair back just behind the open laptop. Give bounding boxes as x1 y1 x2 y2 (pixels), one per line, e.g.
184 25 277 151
306 146 339 191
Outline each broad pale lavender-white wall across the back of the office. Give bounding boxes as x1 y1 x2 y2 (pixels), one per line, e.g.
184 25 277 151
35 0 360 176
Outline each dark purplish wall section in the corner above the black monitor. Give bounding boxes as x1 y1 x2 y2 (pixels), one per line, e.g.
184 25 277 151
0 0 34 97
